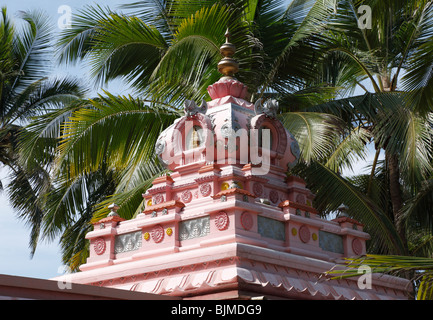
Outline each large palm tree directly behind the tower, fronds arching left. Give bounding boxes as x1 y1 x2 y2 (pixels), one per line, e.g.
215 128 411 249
23 0 356 269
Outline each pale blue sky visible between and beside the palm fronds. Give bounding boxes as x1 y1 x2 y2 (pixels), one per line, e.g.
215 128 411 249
0 0 373 279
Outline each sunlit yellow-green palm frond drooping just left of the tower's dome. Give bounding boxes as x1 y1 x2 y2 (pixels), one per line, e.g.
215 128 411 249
57 93 178 177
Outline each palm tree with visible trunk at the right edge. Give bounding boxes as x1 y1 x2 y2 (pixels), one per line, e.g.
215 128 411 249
296 0 433 255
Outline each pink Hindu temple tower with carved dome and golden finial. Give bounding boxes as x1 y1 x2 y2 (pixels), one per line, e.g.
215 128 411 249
56 30 408 300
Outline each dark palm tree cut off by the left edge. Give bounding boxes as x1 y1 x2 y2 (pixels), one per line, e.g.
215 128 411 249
0 7 83 254
